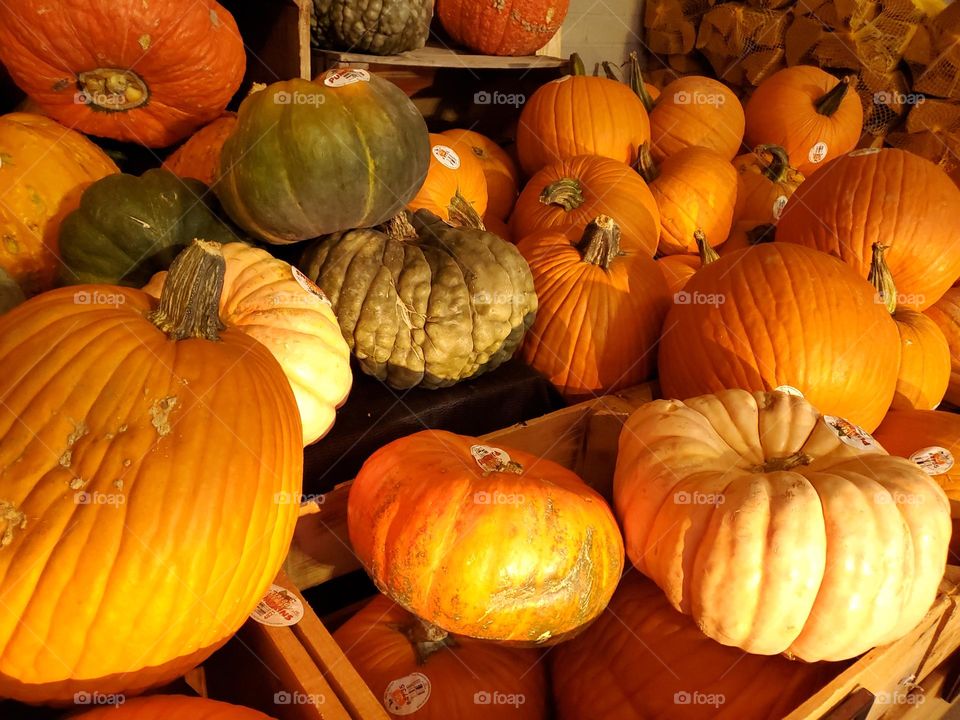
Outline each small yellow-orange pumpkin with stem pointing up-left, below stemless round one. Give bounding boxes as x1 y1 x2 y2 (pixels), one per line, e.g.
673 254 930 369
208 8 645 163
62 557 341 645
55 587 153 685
640 147 737 255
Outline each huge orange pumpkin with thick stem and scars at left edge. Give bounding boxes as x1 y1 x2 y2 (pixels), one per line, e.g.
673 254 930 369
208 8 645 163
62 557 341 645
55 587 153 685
0 243 303 703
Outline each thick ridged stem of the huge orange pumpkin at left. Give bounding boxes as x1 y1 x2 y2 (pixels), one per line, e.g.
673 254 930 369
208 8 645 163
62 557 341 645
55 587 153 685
147 240 226 341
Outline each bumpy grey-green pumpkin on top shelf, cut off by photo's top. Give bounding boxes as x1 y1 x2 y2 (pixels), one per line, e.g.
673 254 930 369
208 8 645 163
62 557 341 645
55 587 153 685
311 0 433 55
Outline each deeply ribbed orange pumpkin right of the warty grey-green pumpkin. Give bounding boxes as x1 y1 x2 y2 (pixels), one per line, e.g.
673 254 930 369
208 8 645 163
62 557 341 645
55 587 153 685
517 215 670 402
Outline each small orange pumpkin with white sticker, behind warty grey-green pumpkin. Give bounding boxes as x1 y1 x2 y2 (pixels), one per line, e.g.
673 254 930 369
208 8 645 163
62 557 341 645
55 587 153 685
407 133 487 227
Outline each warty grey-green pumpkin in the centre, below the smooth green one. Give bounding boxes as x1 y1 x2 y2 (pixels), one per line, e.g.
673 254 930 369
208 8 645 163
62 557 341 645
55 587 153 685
301 210 537 389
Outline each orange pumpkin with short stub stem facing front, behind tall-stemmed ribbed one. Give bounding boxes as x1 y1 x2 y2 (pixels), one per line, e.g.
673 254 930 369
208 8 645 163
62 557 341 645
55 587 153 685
510 155 660 257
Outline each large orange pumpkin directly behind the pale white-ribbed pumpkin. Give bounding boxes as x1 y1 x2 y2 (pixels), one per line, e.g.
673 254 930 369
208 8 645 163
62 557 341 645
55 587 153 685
659 243 900 432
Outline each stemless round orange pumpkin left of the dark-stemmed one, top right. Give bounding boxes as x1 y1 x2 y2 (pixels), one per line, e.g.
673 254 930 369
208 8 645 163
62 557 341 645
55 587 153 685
650 75 744 162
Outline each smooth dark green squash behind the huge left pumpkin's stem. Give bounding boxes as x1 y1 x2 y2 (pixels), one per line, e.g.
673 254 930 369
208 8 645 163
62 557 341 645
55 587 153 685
60 170 240 287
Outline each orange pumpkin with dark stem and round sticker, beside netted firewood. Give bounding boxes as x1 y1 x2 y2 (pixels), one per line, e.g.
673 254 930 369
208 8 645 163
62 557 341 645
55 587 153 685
745 65 863 175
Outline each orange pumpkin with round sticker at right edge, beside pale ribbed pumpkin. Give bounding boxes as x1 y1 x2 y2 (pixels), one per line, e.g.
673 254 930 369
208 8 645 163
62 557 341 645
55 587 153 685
873 410 960 502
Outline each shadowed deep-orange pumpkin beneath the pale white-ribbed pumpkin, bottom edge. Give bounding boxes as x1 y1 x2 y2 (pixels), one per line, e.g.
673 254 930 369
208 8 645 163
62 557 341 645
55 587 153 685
547 571 841 720
